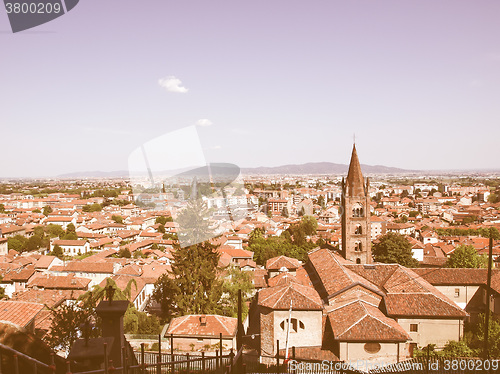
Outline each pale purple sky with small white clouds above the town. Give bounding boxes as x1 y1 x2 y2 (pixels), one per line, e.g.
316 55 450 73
0 0 500 177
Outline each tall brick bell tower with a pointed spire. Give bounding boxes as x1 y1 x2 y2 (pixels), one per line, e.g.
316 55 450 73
341 144 372 264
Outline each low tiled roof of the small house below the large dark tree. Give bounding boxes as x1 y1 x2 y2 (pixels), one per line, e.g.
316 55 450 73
167 314 238 337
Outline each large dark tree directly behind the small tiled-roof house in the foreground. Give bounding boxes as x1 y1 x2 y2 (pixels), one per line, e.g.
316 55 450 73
153 242 222 320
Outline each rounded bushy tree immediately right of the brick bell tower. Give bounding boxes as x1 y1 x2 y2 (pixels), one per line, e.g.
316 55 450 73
372 232 418 267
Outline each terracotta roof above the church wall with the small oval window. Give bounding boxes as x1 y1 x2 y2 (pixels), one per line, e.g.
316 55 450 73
328 301 410 342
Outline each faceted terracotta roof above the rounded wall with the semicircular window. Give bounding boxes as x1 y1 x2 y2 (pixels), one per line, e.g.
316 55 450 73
258 282 323 310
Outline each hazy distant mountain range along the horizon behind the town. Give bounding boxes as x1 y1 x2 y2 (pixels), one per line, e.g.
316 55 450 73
57 162 421 179
